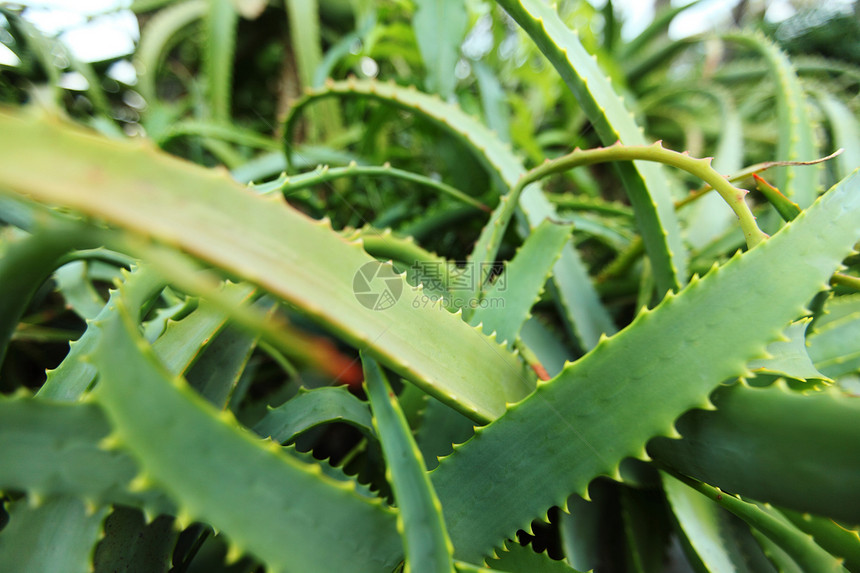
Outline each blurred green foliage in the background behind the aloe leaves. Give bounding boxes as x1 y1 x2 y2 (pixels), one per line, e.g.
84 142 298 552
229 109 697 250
0 0 860 388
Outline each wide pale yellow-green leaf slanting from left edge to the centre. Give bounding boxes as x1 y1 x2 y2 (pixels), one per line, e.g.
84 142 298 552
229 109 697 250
0 106 532 420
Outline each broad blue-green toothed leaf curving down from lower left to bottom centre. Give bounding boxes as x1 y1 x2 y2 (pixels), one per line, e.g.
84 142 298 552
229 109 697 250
93 292 400 571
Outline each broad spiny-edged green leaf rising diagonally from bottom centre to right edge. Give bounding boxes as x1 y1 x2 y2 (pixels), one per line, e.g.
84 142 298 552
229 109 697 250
431 172 860 561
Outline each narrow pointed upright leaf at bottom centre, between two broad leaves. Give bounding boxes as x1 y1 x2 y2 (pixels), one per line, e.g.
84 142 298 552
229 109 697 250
362 356 454 573
